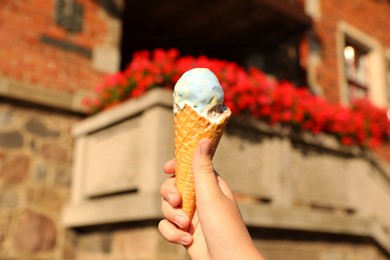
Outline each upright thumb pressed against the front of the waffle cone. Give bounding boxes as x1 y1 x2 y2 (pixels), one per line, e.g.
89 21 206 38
192 139 221 200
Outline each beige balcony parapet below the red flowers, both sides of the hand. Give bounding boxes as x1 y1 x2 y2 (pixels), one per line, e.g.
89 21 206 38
63 88 390 251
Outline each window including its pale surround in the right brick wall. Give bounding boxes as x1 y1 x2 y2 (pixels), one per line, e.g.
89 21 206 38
337 21 384 106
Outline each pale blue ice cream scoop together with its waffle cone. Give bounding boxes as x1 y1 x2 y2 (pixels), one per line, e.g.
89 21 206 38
173 68 231 217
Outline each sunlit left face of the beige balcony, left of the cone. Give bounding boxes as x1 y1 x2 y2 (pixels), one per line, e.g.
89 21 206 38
64 89 174 227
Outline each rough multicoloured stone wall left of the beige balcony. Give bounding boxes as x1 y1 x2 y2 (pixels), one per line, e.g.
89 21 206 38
0 102 79 259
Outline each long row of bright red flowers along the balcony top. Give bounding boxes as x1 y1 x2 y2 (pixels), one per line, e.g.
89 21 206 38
83 49 390 147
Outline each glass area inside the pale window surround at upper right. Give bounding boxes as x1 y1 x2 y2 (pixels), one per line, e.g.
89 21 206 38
344 39 370 100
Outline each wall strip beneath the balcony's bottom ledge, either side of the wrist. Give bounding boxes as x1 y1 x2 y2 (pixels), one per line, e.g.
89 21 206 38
66 222 388 260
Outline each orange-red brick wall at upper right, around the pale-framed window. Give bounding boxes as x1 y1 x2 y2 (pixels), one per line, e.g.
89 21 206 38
314 0 390 102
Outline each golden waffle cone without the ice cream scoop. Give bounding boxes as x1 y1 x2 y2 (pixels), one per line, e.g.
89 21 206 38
174 105 230 218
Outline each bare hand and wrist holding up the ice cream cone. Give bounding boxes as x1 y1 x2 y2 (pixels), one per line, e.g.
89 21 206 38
158 139 264 260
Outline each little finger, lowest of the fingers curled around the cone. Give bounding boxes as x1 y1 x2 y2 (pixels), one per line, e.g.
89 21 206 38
158 219 192 245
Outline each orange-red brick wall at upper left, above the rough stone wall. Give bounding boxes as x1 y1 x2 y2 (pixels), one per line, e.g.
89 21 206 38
0 0 107 92
